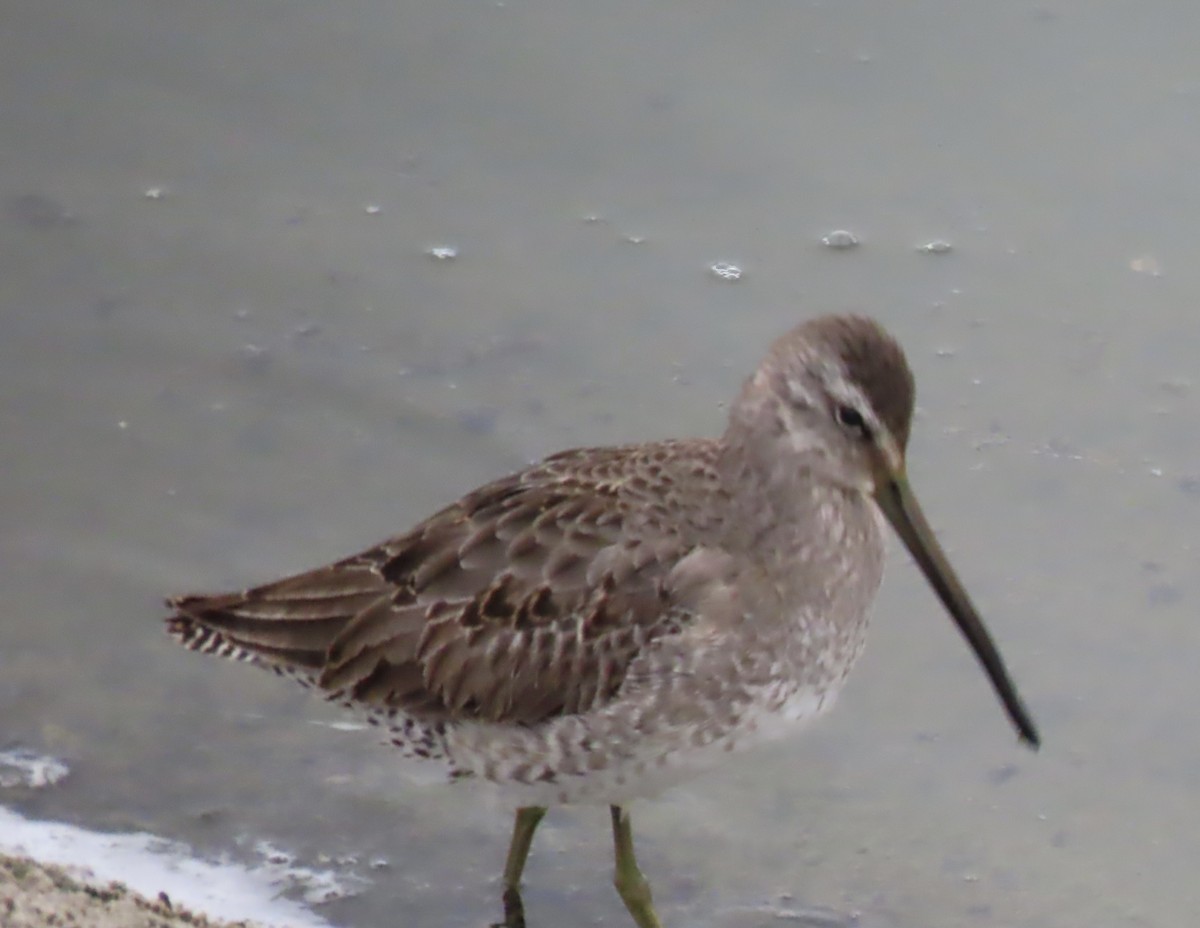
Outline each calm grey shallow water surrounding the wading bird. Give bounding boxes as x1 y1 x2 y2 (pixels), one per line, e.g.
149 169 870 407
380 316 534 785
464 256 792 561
0 0 1200 928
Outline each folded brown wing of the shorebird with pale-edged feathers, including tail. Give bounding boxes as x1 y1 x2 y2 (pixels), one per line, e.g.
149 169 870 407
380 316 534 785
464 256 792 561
168 445 715 724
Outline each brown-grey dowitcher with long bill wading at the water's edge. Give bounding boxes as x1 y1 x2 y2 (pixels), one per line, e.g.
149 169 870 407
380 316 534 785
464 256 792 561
168 316 1038 928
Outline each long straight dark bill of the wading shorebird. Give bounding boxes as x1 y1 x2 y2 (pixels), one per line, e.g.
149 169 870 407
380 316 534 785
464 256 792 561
875 473 1039 748
